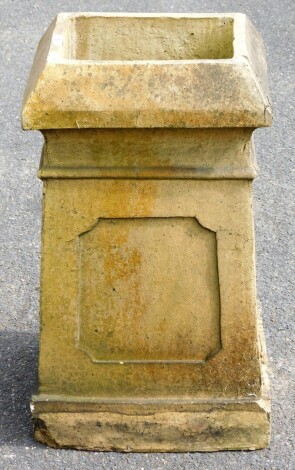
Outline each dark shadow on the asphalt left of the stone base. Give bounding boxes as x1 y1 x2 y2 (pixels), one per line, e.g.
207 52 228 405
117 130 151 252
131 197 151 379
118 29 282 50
0 331 38 445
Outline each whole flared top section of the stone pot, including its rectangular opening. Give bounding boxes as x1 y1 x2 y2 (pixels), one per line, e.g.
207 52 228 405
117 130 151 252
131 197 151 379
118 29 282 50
23 13 271 129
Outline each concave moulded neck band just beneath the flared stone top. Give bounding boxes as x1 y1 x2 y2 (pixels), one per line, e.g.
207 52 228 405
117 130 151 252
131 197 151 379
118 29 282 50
39 128 256 179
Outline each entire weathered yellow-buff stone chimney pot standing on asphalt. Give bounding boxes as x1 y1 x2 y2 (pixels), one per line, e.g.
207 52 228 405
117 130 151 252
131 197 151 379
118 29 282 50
23 14 270 451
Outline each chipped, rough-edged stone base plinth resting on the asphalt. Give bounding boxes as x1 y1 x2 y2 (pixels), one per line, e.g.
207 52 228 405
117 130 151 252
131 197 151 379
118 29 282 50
32 395 270 452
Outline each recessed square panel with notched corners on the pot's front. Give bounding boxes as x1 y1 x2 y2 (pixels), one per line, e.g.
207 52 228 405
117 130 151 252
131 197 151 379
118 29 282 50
78 217 221 362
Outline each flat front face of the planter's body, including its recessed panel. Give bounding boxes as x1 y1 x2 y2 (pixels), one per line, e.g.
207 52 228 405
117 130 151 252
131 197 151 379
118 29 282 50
39 179 261 399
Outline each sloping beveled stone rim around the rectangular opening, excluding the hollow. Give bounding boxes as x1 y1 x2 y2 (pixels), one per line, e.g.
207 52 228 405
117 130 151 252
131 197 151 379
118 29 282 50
22 12 271 129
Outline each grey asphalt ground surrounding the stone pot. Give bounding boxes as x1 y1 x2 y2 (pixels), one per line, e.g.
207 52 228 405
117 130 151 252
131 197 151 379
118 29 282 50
0 0 295 470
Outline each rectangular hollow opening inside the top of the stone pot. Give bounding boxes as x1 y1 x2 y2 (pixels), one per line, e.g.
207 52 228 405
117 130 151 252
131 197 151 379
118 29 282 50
72 16 233 60
